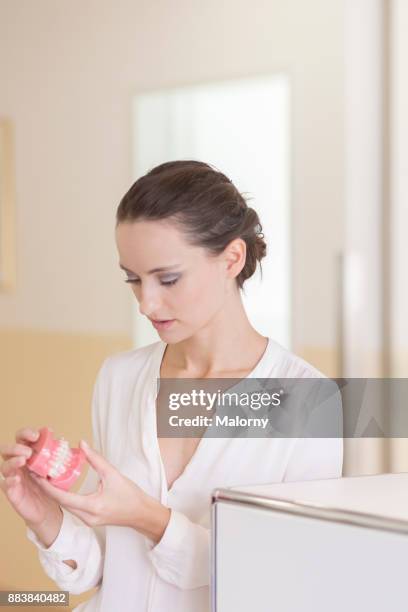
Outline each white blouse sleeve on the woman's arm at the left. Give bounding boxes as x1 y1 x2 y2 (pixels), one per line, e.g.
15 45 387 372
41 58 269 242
26 360 106 594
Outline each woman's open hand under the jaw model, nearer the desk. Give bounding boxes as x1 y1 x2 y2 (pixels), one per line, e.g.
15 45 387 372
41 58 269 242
31 440 170 539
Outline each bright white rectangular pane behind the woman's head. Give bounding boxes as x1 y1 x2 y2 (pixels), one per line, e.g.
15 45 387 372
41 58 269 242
134 74 291 348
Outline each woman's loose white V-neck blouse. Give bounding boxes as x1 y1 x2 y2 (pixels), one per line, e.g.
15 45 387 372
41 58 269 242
27 338 343 612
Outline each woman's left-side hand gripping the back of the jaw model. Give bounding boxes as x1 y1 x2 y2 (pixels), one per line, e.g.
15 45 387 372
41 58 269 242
0 428 62 528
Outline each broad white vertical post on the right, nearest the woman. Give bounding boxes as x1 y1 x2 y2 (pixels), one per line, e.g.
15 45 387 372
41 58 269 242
342 0 386 377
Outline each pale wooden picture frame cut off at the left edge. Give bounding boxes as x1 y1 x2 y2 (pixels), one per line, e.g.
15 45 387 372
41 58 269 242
0 117 16 293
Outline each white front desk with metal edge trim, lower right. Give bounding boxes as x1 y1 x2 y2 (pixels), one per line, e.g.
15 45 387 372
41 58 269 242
211 473 408 612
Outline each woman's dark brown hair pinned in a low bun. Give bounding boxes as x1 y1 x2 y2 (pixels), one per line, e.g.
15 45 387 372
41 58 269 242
116 160 266 289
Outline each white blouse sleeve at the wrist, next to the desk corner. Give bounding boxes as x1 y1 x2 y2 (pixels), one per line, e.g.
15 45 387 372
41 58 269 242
146 509 211 589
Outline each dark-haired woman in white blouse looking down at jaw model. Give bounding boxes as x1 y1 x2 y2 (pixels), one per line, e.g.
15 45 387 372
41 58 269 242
1 161 343 612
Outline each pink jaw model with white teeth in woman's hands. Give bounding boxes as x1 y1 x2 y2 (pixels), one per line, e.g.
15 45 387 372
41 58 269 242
26 427 85 491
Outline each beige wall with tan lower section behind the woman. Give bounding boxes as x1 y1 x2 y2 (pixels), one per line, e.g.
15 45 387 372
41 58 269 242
0 0 344 600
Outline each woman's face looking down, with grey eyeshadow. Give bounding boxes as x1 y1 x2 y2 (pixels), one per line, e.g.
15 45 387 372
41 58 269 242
115 220 245 342
